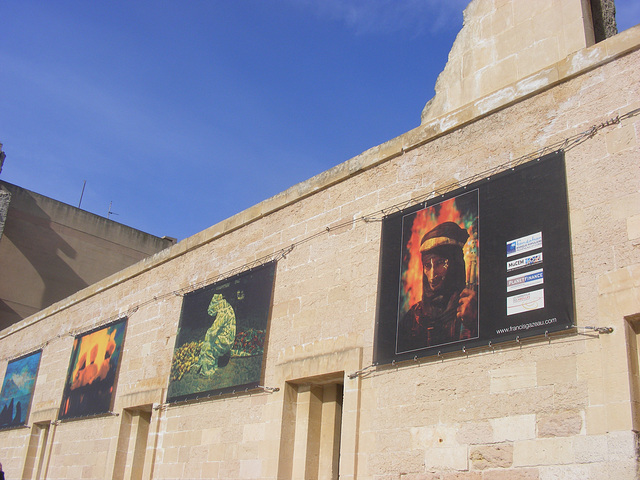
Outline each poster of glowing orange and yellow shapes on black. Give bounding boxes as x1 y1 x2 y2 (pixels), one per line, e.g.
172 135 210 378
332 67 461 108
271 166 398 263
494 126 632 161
58 317 127 420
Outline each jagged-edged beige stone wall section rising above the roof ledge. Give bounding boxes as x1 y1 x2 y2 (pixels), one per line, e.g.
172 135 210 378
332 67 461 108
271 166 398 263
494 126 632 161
422 0 595 123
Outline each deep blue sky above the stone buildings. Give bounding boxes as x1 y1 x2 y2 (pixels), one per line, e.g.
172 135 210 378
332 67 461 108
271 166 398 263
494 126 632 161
0 0 640 240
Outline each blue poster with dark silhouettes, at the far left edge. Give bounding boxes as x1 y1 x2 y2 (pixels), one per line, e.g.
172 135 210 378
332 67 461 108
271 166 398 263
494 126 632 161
0 350 42 429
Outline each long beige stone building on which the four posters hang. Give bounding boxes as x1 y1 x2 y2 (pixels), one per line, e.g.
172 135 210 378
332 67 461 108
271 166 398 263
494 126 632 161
0 0 640 480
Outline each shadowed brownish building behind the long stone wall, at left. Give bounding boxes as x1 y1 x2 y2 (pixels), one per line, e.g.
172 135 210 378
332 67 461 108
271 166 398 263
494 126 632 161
0 180 175 329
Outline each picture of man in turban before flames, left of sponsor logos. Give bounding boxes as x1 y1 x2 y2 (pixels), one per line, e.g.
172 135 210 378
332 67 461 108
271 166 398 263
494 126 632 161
396 190 479 353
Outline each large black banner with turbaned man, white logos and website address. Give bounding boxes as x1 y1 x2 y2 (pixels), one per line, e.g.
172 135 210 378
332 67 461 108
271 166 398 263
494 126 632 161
374 152 574 364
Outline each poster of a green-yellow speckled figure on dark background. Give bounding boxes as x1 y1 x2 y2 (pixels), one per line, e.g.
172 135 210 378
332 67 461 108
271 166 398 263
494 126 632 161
167 261 276 402
